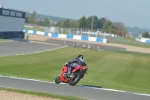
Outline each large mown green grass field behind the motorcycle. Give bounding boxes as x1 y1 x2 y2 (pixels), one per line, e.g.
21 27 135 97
0 47 150 94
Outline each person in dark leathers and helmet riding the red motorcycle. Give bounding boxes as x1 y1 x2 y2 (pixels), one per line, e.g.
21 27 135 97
66 55 86 76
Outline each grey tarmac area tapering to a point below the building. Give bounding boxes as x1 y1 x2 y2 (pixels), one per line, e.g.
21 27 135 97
0 40 64 56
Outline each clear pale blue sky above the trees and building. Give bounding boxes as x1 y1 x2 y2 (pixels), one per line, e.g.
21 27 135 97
0 0 150 29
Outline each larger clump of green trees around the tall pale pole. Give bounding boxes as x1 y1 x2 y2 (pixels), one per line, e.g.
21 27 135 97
56 16 127 37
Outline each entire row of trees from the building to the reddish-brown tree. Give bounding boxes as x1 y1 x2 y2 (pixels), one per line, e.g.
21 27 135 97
25 11 127 37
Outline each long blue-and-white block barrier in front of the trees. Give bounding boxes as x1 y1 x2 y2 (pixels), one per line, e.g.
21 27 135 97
23 30 107 43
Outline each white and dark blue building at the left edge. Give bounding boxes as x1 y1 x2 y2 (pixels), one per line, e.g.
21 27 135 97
0 6 25 39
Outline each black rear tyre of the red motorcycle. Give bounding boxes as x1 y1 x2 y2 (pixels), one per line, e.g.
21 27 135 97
69 73 81 86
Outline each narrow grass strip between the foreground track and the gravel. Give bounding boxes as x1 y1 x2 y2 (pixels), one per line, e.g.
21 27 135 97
0 87 85 100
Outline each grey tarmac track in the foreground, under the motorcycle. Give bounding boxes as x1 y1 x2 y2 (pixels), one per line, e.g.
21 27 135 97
0 76 150 100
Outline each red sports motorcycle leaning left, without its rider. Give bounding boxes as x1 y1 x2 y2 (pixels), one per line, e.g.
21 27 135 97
55 65 88 86
